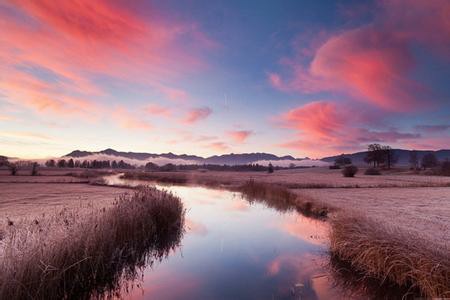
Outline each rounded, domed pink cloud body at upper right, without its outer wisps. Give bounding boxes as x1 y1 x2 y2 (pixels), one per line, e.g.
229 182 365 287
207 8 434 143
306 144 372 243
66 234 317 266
310 27 425 111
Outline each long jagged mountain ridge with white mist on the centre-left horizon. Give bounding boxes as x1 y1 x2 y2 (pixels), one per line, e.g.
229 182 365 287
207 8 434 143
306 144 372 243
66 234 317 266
64 149 303 165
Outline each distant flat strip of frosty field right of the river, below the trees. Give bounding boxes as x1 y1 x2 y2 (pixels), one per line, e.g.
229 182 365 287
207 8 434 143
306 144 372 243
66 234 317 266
121 168 450 188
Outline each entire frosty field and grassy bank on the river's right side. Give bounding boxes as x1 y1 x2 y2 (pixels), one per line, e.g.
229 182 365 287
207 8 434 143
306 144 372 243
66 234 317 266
118 169 450 297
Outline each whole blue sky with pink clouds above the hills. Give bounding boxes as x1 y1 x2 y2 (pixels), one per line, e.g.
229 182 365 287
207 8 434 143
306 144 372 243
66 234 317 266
0 0 450 158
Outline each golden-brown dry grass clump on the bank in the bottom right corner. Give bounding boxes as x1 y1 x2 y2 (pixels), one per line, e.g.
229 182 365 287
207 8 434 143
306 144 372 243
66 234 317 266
330 214 450 297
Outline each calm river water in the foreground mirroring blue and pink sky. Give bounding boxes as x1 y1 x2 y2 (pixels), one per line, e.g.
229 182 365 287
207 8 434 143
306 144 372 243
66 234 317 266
105 177 348 299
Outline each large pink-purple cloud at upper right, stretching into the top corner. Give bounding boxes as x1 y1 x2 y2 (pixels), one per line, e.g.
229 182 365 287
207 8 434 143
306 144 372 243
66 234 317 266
268 0 450 112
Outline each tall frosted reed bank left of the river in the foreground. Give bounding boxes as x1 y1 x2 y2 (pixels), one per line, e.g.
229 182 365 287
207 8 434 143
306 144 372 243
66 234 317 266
0 188 184 299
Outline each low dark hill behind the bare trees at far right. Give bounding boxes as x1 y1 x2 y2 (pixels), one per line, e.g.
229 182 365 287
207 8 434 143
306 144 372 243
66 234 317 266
322 149 450 166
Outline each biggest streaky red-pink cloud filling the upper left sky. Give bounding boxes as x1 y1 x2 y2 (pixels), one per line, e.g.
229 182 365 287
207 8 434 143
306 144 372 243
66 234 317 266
0 0 212 116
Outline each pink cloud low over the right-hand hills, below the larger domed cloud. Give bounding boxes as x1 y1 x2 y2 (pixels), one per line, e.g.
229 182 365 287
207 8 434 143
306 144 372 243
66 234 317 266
280 101 421 156
